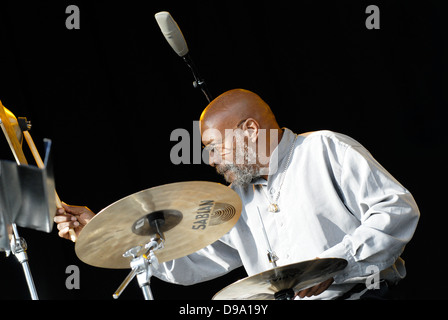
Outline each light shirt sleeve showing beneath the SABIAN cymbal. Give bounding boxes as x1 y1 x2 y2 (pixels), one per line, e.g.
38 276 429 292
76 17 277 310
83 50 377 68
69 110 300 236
153 236 242 285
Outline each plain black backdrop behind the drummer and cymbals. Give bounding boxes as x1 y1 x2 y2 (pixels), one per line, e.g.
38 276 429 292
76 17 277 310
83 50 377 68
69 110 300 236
0 0 448 300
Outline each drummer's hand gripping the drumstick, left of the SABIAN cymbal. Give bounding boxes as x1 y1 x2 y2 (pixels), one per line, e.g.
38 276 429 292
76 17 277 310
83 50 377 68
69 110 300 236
54 203 95 240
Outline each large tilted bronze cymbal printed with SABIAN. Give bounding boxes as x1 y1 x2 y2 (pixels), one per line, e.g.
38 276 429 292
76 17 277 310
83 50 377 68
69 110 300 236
75 181 242 269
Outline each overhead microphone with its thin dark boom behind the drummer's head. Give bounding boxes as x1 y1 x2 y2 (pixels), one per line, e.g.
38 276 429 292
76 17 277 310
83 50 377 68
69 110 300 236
154 11 212 103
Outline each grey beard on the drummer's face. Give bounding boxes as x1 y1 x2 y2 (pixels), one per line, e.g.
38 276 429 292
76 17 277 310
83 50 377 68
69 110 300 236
216 141 261 187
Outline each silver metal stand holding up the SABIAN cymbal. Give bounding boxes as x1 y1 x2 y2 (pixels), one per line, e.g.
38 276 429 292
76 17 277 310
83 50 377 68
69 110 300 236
112 220 165 300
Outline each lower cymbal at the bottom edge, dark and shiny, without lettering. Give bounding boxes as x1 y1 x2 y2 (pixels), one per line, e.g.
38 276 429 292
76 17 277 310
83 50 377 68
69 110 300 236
213 258 347 300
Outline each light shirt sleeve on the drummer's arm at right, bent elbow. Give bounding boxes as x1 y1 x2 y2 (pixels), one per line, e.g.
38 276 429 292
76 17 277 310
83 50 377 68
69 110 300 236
319 146 420 283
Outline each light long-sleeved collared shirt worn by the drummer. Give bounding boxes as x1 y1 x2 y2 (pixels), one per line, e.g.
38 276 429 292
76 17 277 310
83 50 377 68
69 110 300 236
154 128 420 299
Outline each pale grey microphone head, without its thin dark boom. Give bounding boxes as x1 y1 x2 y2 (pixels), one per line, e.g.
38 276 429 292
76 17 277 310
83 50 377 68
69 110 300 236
154 11 188 57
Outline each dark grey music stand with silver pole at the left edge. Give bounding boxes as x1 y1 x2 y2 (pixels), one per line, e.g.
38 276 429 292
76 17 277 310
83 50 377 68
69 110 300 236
0 140 56 300
